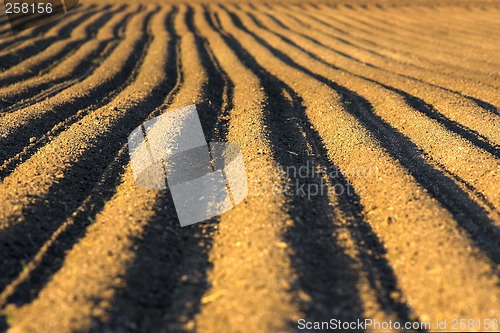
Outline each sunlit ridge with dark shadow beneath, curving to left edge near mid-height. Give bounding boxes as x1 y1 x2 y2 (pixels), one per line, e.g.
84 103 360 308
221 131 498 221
0 6 149 175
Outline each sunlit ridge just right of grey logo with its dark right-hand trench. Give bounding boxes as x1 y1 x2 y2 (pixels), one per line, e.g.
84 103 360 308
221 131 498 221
197 4 418 332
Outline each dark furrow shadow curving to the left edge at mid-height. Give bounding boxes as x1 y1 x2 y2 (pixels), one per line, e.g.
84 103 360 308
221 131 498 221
0 7 153 179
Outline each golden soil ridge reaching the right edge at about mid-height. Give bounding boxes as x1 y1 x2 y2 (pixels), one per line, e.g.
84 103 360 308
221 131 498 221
253 2 500 214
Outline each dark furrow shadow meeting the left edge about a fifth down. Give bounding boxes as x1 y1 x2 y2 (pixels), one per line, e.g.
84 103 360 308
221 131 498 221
0 6 104 68
